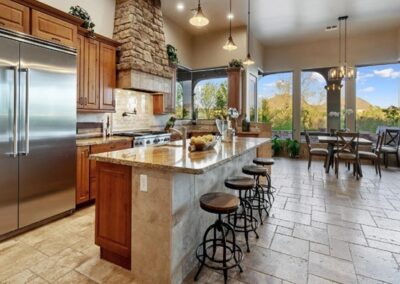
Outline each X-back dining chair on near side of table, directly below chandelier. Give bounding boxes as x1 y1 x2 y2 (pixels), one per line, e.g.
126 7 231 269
334 132 361 180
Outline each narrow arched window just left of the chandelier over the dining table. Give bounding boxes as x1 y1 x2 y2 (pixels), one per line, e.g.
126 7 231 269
301 71 327 132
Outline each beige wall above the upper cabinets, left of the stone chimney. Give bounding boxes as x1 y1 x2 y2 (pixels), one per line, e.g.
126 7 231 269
39 0 115 38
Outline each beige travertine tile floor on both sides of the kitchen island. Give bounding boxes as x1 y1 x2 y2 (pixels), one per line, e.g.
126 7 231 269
0 159 400 284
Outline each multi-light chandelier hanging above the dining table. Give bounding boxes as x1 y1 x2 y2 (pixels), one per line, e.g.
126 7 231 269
328 16 356 81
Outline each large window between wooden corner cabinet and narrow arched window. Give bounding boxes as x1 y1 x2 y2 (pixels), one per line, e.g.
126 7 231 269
257 72 293 138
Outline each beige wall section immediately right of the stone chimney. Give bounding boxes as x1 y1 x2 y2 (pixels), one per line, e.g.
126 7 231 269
164 17 193 68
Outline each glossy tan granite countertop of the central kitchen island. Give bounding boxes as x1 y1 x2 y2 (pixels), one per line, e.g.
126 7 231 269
89 137 271 174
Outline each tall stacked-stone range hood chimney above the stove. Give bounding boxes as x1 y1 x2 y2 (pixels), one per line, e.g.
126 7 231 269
114 0 173 91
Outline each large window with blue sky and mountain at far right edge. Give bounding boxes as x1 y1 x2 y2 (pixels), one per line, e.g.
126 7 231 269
356 64 400 136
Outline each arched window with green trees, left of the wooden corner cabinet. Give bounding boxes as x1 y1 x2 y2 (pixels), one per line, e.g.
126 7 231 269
194 77 228 119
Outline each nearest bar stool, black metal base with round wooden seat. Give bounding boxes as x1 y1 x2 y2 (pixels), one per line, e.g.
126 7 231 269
194 192 243 283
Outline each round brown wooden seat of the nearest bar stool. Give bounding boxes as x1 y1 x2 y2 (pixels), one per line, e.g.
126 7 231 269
200 192 240 214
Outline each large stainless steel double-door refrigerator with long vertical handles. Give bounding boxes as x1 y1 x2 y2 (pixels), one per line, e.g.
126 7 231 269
0 29 77 239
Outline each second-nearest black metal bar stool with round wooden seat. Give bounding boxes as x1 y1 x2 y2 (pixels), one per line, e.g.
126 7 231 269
225 176 258 252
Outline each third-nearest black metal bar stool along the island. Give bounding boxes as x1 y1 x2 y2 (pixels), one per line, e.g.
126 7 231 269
242 165 269 225
